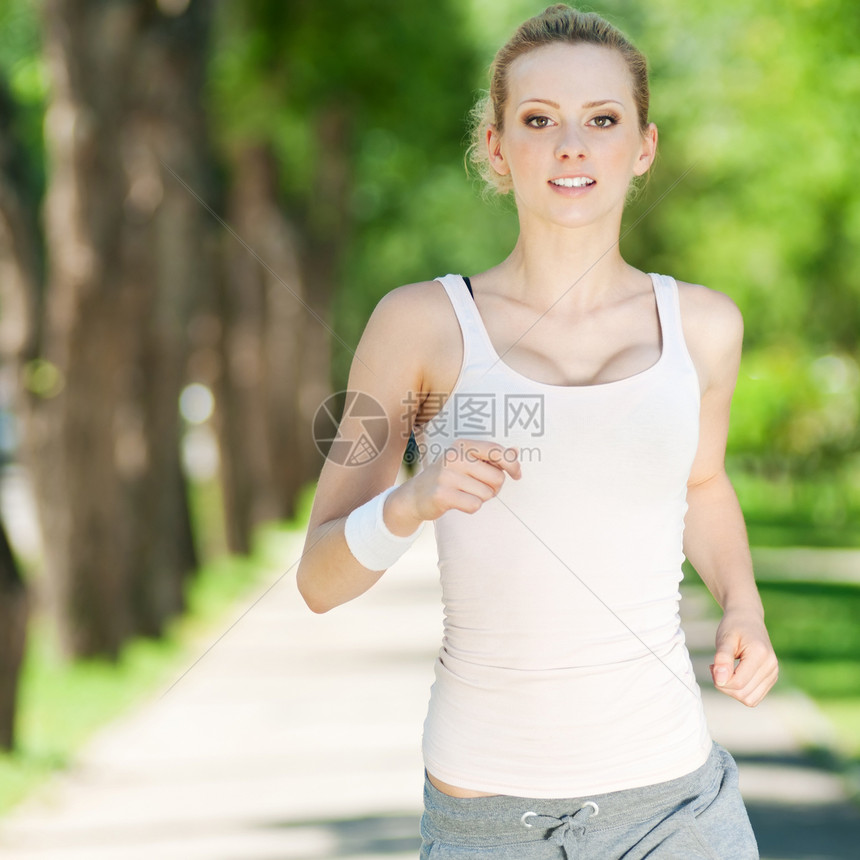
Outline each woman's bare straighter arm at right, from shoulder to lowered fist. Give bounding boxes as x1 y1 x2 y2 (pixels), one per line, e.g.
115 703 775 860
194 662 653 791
682 287 778 706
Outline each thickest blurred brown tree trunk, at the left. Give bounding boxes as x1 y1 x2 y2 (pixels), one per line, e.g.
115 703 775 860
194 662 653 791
33 0 210 656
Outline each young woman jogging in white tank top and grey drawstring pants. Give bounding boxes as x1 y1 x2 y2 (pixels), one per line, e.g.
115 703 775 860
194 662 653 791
298 5 777 860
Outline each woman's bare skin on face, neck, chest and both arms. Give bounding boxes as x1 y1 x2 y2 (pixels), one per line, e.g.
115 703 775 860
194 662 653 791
297 44 778 797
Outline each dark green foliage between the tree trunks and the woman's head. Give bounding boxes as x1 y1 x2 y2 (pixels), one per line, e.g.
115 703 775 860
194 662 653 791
209 0 496 386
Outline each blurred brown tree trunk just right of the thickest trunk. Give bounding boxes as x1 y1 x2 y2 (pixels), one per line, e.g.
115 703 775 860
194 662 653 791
217 144 307 552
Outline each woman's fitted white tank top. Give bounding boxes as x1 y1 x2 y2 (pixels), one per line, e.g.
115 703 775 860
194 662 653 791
415 274 711 798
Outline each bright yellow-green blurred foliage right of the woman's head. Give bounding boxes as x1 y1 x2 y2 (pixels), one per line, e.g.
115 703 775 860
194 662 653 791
620 0 860 351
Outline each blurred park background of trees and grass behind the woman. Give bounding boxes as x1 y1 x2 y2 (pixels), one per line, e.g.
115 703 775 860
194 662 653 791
0 0 860 852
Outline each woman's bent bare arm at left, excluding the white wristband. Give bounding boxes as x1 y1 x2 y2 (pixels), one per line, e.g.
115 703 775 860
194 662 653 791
296 284 519 612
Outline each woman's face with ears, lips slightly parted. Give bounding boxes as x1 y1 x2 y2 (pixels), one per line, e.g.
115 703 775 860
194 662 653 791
487 44 657 227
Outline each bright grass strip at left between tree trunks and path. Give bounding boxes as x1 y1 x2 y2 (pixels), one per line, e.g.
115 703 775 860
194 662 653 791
0 504 312 815
